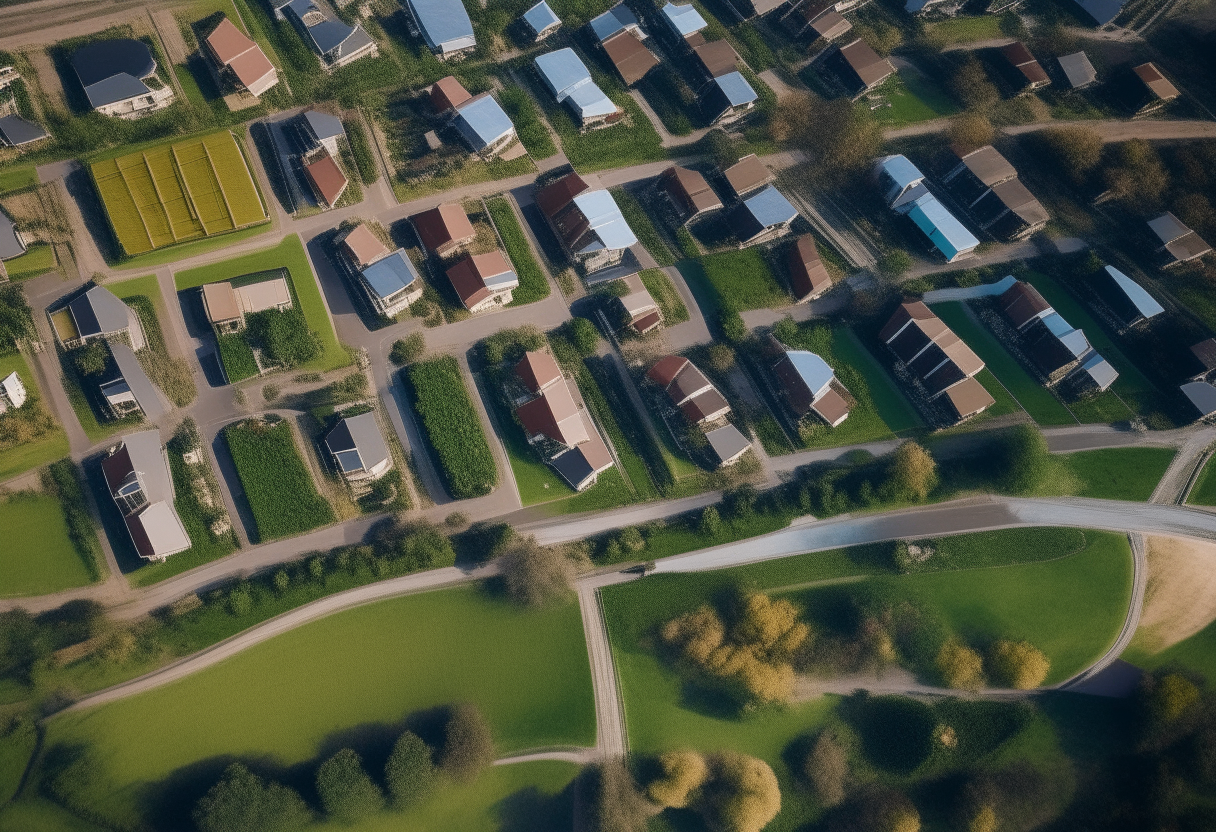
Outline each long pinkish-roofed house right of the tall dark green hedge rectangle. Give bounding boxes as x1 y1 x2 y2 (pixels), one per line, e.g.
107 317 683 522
516 352 613 491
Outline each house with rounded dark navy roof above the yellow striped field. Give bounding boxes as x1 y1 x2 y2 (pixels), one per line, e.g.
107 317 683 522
72 38 173 118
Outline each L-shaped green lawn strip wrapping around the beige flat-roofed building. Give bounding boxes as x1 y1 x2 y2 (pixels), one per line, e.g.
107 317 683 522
174 234 350 372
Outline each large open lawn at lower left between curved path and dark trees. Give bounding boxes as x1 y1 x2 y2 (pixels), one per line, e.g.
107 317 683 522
46 586 595 828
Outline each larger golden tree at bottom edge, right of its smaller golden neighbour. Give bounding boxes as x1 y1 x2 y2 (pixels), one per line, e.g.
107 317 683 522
700 751 781 832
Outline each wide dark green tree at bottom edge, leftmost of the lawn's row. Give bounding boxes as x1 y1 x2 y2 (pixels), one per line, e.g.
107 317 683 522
193 763 313 832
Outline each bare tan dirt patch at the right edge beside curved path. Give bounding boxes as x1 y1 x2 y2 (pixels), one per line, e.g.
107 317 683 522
1136 538 1216 652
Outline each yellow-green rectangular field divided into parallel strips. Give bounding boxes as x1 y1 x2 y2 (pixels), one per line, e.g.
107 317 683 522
90 130 268 255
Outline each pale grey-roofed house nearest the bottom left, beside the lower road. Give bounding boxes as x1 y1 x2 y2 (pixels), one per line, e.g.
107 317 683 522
101 431 191 561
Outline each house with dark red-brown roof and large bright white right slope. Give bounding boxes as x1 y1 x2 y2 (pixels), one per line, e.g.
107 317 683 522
535 172 637 274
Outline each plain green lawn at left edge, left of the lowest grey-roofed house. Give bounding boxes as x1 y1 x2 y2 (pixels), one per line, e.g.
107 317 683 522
0 494 92 597
